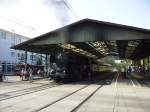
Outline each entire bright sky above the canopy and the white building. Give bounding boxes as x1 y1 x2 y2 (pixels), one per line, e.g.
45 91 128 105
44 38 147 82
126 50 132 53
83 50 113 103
0 0 150 38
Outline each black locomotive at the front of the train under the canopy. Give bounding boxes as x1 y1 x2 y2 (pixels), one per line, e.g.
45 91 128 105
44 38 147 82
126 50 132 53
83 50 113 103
50 52 90 81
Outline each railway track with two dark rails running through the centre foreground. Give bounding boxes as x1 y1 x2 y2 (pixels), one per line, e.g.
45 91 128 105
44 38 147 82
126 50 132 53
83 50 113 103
32 84 103 112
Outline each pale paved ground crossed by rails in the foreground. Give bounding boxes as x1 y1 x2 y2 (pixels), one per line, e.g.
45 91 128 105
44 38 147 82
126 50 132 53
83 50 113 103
0 73 150 112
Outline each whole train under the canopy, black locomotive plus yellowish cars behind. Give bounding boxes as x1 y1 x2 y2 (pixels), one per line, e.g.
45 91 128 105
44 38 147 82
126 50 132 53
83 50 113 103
49 52 113 82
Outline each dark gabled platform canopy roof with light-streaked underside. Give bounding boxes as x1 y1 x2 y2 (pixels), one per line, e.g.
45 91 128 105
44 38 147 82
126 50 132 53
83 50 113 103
12 19 150 59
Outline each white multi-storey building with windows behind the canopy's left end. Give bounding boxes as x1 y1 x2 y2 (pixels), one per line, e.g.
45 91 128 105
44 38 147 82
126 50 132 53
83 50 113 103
0 29 39 73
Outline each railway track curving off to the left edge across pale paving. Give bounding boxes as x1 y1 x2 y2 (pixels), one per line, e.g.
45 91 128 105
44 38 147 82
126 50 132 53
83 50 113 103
0 84 62 101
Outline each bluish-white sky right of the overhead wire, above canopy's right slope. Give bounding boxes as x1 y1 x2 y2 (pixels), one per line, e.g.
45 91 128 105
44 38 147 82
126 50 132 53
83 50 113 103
68 0 150 29
